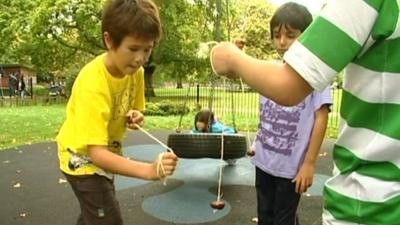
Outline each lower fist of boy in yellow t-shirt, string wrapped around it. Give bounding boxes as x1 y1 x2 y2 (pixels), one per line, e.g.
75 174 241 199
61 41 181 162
153 152 178 179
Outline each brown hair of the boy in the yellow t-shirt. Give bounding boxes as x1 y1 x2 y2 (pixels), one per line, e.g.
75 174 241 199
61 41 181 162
101 0 162 47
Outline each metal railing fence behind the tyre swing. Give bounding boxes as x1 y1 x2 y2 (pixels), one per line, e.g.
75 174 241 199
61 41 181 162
146 84 342 138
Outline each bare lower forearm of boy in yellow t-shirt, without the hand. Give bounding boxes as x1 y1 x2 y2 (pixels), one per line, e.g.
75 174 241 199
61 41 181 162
89 146 157 180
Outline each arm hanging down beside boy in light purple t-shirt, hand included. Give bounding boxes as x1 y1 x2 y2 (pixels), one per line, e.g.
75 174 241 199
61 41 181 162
293 105 329 193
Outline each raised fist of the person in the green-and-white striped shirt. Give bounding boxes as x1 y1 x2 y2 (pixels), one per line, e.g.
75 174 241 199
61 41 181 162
210 42 241 78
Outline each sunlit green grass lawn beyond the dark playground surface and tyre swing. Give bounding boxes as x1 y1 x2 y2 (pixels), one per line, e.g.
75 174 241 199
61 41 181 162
0 104 257 150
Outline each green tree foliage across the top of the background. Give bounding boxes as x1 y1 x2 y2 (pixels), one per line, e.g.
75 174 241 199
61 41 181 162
0 0 280 86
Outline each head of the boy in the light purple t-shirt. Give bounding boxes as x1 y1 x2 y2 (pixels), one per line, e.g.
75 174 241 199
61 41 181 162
270 2 312 56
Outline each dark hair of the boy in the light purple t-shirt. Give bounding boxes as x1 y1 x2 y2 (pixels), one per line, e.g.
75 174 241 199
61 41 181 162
269 2 313 38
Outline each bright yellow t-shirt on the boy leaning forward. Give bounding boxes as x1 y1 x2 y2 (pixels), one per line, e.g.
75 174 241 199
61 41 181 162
57 54 145 175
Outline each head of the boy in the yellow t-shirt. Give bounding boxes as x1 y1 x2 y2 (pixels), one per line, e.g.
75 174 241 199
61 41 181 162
101 0 162 76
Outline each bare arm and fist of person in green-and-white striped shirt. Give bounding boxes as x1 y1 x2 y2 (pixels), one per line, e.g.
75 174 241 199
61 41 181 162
211 42 313 106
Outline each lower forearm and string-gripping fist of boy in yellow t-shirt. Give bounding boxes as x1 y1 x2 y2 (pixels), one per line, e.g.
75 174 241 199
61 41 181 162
88 145 178 180
